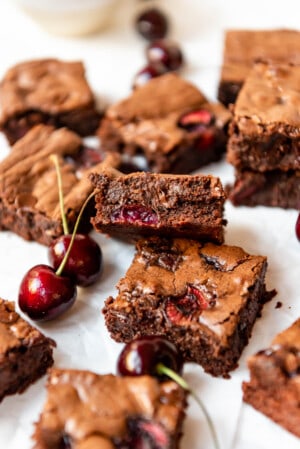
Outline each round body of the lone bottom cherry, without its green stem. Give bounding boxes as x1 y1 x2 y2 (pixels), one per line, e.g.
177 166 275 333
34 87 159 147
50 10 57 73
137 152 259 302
117 335 183 377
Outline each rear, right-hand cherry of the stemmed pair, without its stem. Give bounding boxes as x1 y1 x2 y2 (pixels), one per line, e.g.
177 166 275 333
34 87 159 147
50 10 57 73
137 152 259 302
48 234 102 287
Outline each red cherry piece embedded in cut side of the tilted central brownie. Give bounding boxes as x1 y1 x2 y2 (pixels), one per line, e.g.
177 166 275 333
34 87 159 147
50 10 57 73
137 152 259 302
111 204 158 225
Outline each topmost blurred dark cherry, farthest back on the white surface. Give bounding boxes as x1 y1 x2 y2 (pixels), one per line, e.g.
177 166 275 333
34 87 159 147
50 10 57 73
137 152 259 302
135 8 169 41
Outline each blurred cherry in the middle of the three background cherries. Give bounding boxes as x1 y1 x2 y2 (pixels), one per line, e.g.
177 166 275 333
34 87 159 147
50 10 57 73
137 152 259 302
146 39 183 71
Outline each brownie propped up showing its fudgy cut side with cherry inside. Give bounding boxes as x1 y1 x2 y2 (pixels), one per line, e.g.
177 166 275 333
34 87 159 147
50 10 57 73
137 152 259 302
90 170 225 243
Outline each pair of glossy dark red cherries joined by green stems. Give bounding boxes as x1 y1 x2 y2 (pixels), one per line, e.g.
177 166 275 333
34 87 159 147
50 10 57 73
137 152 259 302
19 156 102 321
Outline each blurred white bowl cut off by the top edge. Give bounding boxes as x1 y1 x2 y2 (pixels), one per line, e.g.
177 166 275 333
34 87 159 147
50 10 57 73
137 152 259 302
15 0 120 36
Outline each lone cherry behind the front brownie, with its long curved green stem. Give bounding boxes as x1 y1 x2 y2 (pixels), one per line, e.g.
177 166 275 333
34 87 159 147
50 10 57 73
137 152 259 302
117 335 220 449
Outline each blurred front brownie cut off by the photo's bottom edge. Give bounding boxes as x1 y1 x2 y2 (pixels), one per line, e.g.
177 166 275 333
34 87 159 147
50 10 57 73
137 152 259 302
33 369 186 449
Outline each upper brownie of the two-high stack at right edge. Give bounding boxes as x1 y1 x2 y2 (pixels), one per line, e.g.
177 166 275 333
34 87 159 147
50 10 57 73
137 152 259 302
227 63 300 172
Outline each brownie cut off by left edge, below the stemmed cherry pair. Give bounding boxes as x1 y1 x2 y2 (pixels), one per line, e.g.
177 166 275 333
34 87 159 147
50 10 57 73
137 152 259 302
0 298 55 402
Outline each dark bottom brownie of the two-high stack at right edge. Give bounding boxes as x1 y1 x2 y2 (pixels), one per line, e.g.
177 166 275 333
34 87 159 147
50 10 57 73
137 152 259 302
226 170 300 210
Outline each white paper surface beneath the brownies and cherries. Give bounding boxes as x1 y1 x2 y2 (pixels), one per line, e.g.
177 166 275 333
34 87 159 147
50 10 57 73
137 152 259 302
0 0 300 449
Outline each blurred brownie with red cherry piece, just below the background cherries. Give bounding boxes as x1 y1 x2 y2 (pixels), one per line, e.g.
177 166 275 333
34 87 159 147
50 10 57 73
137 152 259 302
99 73 230 173
